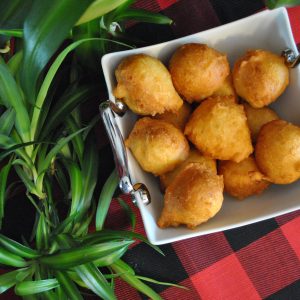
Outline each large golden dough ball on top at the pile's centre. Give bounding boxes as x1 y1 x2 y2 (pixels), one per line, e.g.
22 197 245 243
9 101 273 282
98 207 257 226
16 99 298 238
184 96 253 162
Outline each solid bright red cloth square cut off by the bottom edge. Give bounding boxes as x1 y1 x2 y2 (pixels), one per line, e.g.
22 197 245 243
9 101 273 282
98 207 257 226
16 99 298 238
191 254 261 300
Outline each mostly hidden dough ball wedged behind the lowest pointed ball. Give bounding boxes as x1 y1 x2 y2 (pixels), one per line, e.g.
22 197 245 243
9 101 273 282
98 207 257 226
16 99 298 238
159 149 217 190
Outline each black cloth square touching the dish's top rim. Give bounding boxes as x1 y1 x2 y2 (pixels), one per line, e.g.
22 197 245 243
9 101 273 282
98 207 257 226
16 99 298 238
210 0 265 24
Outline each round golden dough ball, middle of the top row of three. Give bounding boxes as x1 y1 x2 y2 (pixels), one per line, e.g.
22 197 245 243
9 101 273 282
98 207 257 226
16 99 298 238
169 44 230 103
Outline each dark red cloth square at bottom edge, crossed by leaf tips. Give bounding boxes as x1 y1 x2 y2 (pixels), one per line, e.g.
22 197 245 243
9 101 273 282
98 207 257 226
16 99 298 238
160 278 201 300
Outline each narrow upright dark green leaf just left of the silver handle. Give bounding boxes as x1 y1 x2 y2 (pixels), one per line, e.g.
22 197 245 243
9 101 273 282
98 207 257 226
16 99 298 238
81 134 99 209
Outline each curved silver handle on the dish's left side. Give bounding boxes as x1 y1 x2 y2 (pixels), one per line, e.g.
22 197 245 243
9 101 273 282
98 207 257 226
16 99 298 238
100 100 151 205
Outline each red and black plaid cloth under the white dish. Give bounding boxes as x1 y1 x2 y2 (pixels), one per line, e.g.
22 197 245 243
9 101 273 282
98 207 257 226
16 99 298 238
109 0 300 300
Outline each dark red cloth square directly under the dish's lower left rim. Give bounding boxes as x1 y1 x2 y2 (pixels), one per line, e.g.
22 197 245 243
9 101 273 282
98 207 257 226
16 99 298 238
173 232 233 275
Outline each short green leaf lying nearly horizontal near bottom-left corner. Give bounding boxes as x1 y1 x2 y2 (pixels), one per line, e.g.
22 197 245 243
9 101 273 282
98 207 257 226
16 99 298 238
15 279 59 296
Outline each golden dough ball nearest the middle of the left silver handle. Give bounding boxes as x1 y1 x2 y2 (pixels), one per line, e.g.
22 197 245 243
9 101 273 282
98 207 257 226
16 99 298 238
125 117 189 175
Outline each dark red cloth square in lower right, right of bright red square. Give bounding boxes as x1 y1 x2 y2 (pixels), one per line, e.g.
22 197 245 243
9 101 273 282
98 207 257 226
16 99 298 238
236 229 300 298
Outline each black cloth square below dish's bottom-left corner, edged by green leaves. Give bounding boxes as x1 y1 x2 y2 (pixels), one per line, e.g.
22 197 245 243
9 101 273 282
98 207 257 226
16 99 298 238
123 243 189 293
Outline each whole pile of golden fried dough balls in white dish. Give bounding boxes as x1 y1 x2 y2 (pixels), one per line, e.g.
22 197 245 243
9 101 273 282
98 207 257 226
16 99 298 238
114 43 300 228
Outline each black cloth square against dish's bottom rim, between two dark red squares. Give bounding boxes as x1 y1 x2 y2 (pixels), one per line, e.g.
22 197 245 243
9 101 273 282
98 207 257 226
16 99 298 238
224 219 279 251
